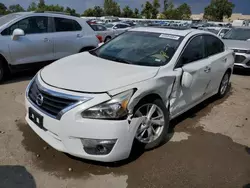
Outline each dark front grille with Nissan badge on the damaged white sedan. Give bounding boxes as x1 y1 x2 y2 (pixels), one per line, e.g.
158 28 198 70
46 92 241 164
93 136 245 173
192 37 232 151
28 81 77 117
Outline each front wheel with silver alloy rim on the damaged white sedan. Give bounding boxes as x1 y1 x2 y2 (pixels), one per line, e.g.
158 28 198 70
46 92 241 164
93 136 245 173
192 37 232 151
134 99 169 150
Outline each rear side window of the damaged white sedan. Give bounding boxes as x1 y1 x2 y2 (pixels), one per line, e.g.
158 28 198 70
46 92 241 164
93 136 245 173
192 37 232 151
205 35 224 56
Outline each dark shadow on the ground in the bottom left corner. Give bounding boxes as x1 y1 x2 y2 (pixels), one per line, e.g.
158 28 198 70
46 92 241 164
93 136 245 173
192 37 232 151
0 166 36 188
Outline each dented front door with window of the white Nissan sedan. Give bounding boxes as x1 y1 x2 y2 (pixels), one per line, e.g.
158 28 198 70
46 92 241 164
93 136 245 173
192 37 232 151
170 35 211 117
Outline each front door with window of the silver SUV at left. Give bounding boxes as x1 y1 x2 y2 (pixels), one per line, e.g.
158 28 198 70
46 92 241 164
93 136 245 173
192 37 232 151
9 16 54 65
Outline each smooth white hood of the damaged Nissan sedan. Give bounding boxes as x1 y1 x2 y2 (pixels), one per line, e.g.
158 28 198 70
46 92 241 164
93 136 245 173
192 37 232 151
40 52 159 93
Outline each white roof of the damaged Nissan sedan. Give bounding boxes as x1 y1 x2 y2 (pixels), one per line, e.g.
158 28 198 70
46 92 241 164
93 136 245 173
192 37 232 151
130 27 201 37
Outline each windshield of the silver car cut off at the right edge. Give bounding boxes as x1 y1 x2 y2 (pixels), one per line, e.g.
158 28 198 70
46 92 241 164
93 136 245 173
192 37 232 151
223 28 250 40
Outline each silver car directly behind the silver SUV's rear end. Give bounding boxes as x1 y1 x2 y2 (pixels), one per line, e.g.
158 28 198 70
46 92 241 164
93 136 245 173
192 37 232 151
90 24 115 42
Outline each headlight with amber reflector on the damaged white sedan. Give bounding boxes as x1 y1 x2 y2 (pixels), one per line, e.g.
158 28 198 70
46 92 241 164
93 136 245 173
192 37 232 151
82 89 134 119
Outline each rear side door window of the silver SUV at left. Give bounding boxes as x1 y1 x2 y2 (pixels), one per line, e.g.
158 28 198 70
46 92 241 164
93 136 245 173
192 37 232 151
55 18 82 32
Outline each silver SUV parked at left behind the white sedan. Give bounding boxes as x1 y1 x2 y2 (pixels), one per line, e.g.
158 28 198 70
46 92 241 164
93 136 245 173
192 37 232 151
0 12 99 81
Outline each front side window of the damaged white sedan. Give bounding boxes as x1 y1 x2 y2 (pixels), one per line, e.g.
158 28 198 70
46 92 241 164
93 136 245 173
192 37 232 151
181 36 205 64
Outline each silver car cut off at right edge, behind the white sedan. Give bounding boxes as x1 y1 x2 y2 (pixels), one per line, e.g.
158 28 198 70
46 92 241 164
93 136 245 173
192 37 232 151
223 27 250 70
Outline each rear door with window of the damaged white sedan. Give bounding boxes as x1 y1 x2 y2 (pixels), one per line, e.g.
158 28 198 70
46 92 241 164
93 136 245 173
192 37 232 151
204 35 230 93
